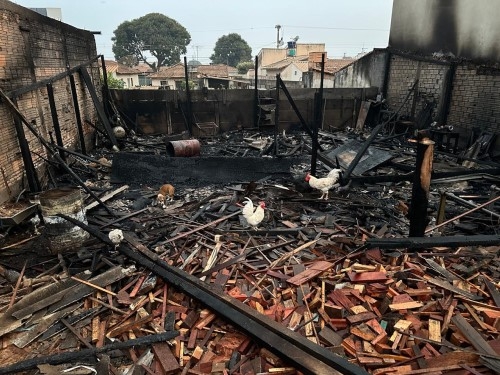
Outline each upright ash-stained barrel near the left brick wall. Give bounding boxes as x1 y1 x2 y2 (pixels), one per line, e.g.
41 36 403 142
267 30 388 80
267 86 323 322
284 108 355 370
40 187 89 254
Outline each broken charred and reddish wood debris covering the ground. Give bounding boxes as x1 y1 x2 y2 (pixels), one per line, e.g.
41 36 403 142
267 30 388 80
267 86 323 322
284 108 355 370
0 126 500 375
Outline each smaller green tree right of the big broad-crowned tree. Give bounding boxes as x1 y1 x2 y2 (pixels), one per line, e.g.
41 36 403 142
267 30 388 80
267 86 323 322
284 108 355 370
210 33 252 67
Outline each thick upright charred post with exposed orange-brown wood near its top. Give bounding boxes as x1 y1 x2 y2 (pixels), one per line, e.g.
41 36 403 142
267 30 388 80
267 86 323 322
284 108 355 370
409 136 434 237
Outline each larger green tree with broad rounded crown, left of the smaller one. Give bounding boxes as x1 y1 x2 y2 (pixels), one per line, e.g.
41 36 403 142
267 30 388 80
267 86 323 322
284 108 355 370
111 13 191 71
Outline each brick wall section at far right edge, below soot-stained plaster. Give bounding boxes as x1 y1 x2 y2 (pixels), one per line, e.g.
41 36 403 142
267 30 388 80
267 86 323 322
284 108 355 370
447 64 500 142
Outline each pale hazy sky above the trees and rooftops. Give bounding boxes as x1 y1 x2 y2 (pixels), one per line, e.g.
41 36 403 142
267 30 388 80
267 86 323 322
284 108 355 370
13 0 393 64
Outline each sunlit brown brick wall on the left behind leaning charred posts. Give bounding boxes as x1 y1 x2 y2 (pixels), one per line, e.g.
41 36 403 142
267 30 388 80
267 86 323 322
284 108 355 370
0 0 100 202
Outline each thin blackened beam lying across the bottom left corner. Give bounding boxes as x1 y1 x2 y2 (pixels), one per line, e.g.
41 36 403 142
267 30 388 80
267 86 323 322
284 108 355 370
0 331 179 375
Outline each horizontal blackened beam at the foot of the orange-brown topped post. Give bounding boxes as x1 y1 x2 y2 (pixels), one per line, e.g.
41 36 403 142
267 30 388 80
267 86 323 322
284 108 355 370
366 234 500 249
